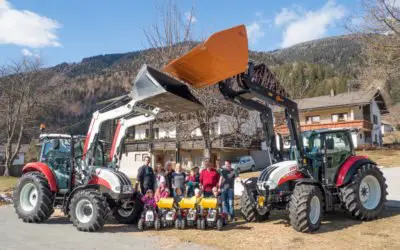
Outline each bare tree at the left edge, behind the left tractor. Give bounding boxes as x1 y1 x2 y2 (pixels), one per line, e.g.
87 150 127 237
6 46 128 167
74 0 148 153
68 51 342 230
0 58 58 175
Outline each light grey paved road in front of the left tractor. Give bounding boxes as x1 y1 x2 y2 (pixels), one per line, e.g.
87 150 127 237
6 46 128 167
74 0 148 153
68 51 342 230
0 206 206 250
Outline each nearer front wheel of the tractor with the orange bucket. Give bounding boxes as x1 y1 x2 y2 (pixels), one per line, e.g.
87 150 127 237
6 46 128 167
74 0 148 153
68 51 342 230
289 184 324 233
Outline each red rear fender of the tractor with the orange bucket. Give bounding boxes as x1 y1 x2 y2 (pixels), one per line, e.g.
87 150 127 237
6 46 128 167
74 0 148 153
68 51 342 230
336 156 376 187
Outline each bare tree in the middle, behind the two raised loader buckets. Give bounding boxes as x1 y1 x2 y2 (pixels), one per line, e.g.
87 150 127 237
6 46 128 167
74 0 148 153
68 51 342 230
144 1 256 158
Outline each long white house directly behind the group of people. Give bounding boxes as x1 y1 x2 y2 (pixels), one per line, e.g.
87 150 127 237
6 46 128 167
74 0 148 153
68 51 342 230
120 115 267 177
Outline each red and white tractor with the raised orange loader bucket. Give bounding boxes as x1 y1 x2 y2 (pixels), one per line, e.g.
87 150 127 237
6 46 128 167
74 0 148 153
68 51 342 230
159 25 387 232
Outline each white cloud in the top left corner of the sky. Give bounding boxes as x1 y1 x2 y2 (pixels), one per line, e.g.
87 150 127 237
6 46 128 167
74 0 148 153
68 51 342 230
0 0 61 48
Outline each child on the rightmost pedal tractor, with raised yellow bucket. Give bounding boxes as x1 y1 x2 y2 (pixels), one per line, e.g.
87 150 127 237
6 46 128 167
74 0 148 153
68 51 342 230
200 187 226 231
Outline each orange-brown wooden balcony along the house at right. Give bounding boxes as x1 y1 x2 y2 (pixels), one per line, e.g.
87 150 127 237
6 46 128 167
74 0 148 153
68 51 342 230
275 120 372 134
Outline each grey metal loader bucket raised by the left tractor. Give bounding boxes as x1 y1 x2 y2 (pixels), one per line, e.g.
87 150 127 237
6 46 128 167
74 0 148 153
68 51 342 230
131 64 203 113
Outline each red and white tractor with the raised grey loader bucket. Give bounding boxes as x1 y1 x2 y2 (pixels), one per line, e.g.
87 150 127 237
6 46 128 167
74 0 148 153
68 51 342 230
14 65 201 232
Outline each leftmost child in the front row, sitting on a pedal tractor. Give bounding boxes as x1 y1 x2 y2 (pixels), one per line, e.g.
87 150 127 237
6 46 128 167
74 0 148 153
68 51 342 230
138 189 161 231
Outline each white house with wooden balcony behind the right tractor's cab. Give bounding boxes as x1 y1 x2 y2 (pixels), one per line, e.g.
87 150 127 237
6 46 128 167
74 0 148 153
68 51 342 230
276 90 388 148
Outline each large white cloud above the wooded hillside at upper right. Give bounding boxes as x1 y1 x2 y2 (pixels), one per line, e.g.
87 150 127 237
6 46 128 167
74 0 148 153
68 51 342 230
275 0 346 47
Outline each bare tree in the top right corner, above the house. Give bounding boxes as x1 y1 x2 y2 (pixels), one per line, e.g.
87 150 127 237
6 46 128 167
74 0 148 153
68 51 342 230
348 0 400 95
